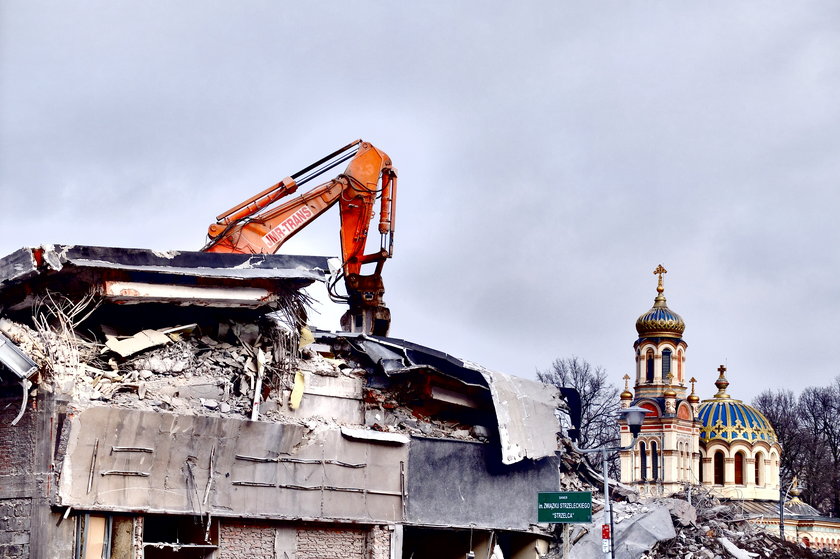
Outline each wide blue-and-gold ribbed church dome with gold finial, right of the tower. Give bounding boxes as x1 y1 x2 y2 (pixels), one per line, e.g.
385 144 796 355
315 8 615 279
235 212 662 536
697 366 777 444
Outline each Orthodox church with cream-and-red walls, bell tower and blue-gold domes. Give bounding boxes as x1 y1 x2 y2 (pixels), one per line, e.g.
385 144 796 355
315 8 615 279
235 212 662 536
621 266 781 500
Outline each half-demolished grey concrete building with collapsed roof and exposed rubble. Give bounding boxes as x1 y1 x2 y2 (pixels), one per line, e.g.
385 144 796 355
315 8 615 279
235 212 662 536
0 246 568 559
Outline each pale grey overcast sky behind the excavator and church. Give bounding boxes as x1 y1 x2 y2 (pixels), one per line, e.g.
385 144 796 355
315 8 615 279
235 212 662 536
0 0 840 401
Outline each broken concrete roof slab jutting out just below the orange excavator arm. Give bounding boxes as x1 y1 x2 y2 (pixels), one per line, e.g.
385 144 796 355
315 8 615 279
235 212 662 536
0 245 329 310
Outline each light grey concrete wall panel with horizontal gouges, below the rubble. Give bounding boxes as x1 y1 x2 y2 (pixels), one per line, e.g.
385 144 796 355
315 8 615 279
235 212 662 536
59 407 408 521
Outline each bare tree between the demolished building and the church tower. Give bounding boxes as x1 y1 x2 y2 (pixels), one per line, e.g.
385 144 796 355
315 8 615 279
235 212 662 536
537 356 619 475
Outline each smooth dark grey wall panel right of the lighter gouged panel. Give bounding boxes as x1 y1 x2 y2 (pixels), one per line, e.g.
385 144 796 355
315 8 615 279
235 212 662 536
406 437 559 530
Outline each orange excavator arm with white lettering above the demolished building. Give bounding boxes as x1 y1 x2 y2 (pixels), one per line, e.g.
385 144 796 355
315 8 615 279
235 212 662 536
202 140 397 335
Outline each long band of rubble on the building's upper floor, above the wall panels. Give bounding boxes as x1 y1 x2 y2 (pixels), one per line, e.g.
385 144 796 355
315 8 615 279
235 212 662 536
0 302 482 441
